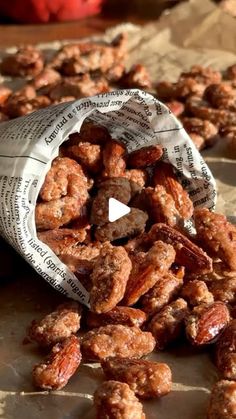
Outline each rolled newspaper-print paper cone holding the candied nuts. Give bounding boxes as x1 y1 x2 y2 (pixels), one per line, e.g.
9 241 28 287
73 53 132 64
0 89 216 305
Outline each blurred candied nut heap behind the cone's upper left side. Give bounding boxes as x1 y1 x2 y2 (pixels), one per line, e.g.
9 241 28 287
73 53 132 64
0 33 151 122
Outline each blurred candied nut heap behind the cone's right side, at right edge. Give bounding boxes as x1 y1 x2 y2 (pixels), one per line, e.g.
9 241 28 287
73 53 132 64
156 64 236 153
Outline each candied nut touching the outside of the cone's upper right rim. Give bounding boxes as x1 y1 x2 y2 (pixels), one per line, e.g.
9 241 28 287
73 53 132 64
181 117 218 146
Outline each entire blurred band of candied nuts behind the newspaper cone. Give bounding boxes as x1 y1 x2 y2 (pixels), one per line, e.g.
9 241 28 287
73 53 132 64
0 33 236 156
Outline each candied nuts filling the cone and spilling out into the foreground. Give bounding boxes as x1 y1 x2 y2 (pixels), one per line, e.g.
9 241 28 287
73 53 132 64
23 121 236 419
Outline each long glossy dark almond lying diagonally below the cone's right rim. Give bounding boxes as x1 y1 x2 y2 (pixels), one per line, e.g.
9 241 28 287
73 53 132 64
149 223 212 274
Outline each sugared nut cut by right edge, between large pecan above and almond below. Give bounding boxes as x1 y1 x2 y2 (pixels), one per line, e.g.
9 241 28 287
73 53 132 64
208 278 236 304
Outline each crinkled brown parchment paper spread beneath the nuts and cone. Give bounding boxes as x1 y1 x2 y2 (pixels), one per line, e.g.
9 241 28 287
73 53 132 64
0 0 236 419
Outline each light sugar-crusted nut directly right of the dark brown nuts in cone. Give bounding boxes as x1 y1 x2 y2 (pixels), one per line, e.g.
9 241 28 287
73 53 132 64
144 185 180 227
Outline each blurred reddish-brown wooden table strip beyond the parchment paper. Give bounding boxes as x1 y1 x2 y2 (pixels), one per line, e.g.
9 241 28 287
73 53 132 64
0 16 147 48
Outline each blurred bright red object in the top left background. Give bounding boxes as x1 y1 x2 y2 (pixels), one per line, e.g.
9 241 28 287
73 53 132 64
0 0 104 23
